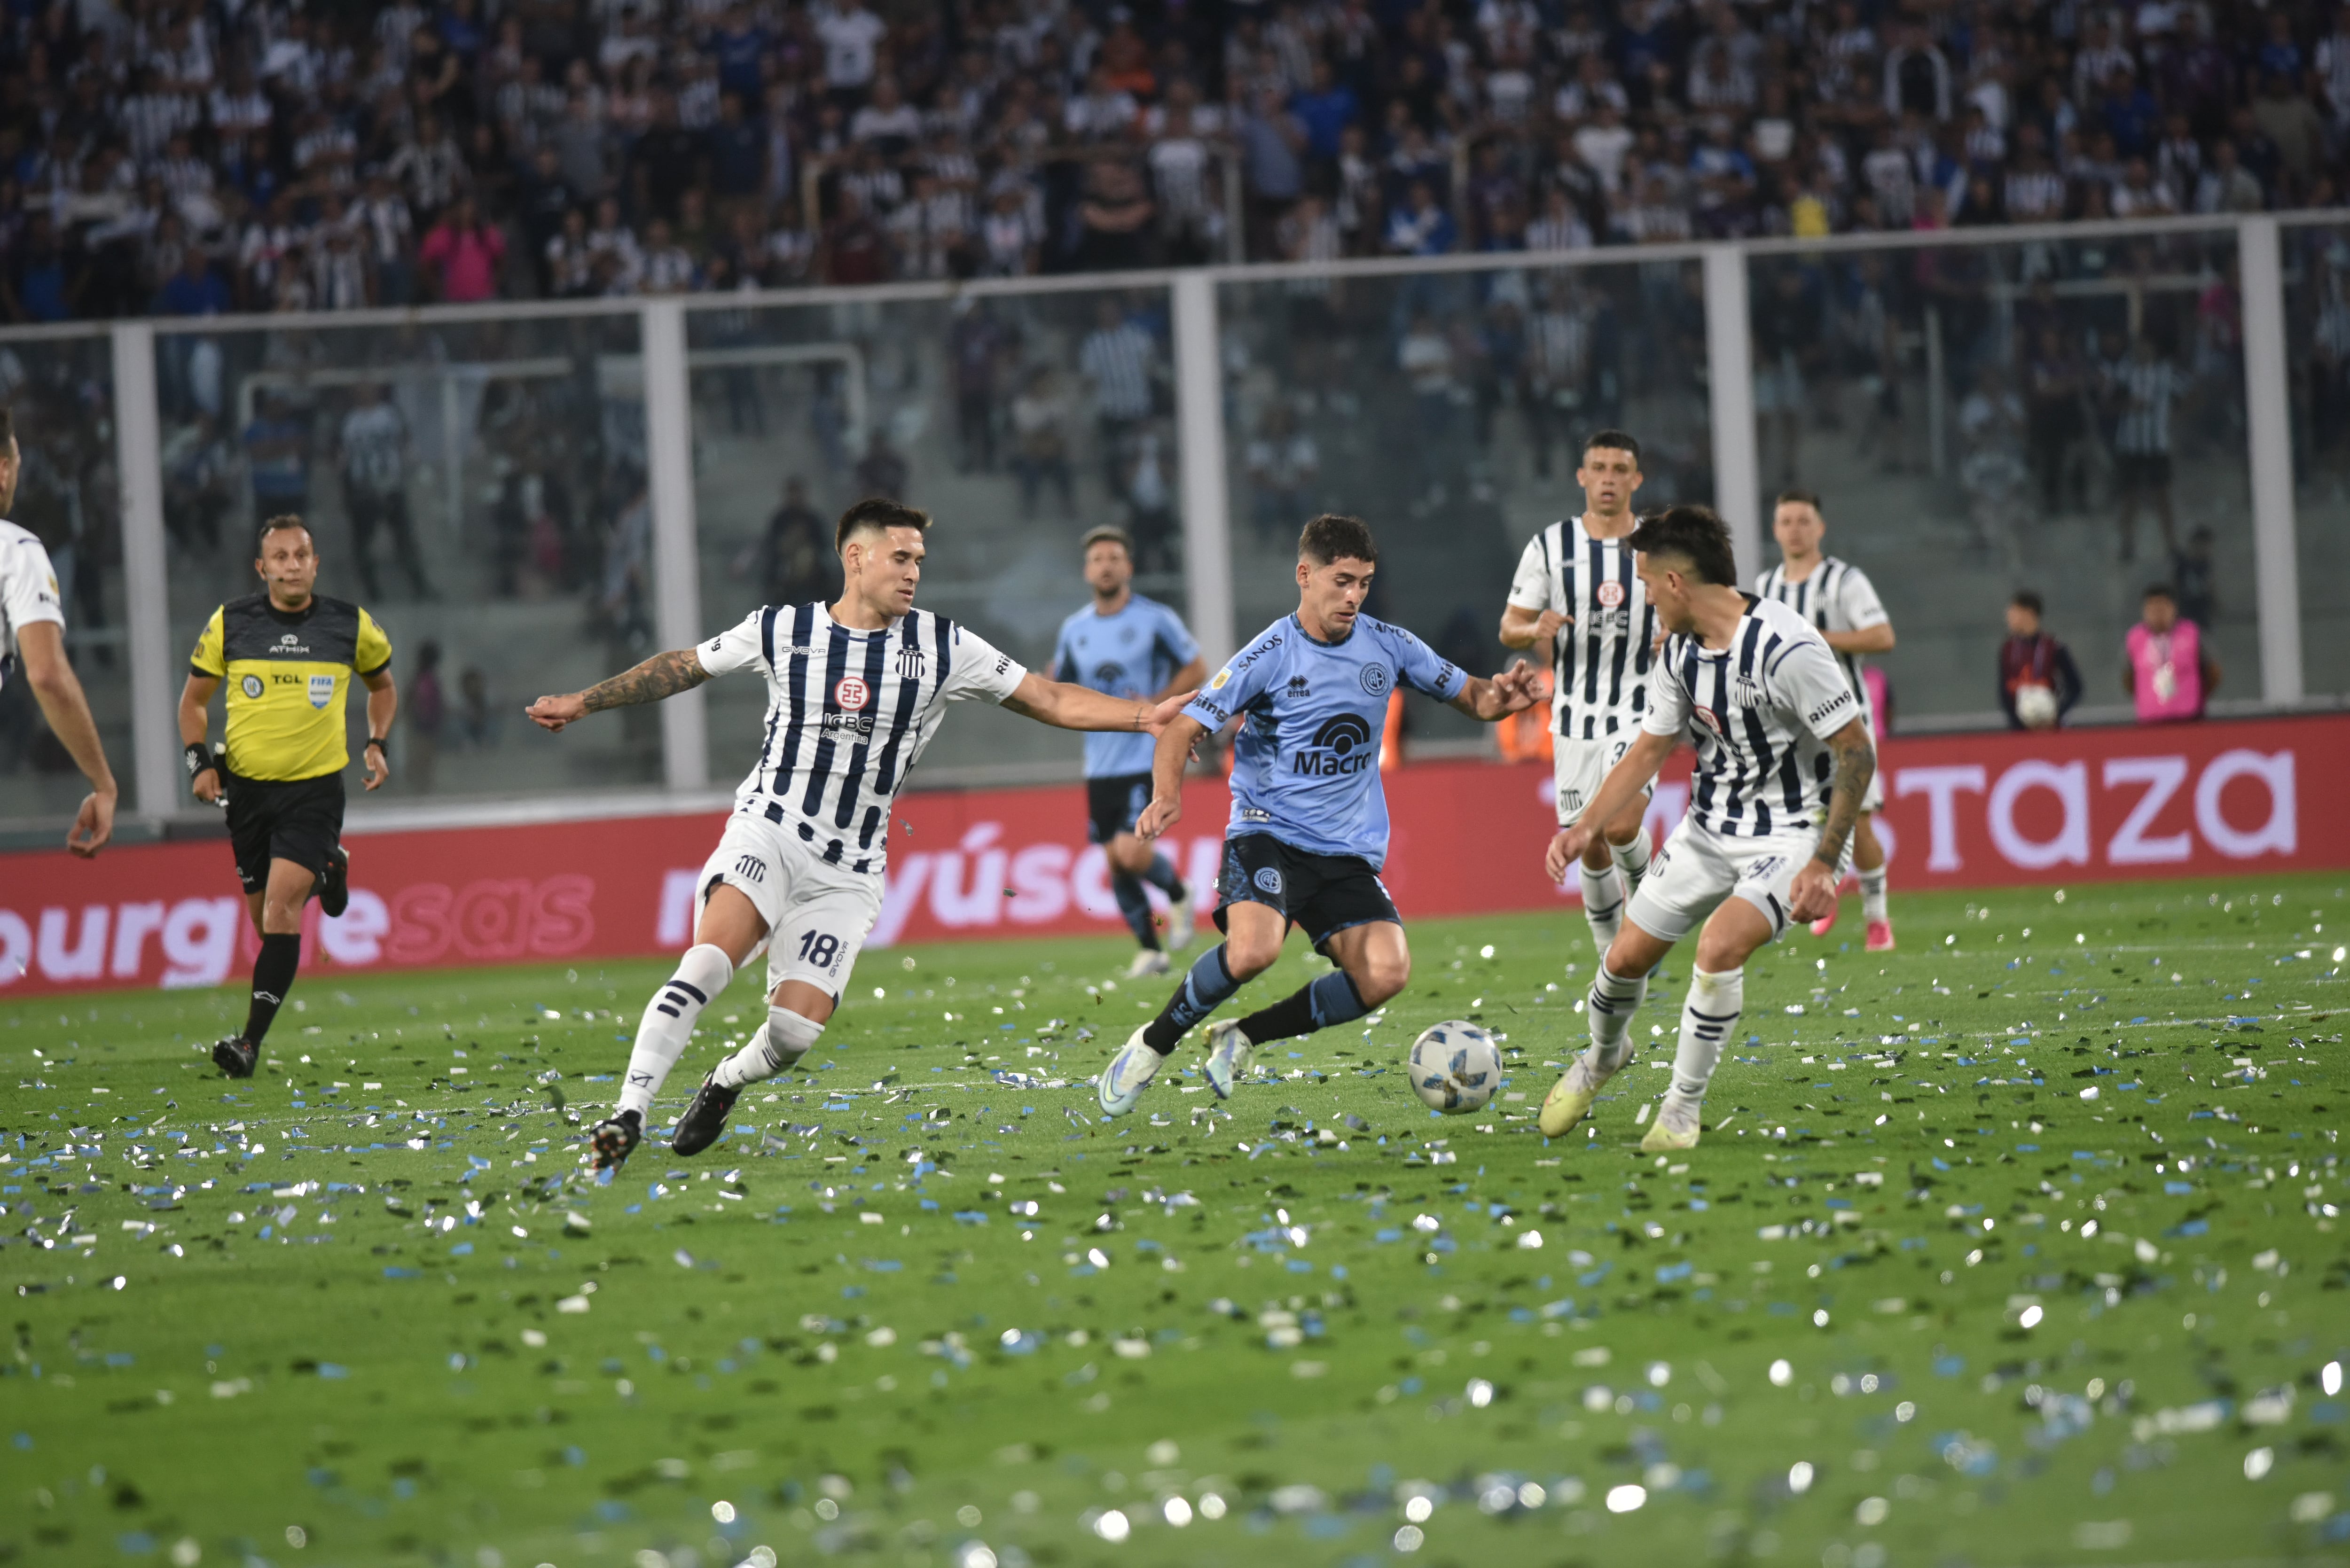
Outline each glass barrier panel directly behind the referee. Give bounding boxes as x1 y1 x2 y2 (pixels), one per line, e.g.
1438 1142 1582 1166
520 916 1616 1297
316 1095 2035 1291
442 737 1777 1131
155 312 663 802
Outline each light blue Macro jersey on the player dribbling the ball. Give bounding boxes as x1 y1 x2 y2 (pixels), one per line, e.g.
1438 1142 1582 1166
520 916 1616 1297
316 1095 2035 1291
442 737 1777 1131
1184 616 1469 870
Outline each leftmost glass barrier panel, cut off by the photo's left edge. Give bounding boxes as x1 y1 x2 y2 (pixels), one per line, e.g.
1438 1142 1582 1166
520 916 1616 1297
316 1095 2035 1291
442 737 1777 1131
0 336 139 839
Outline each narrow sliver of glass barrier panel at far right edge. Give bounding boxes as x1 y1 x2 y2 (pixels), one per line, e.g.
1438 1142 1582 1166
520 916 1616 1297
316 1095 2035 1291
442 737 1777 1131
2280 226 2350 696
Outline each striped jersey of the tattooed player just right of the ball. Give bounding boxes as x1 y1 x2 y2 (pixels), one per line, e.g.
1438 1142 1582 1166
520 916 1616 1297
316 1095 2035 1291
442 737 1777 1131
1640 595 1861 839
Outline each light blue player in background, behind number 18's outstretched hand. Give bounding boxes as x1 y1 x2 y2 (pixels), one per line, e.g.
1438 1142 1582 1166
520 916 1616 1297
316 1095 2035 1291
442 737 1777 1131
1053 527 1208 975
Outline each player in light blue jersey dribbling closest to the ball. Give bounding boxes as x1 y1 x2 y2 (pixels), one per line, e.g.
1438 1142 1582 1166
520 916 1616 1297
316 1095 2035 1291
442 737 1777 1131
1095 515 1535 1116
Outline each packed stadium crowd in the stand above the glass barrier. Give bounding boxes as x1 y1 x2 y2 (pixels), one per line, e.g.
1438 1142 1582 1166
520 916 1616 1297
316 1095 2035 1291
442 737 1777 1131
0 0 2350 322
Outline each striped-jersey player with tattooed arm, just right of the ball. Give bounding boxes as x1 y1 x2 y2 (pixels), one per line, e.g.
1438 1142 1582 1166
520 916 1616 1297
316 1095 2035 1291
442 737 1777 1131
1542 506 1878 1154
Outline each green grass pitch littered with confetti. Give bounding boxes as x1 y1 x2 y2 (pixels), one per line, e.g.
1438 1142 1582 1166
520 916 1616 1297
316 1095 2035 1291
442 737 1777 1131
0 874 2350 1568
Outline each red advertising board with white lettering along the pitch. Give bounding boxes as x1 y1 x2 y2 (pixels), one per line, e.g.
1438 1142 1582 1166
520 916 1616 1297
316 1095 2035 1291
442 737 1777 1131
0 717 2350 997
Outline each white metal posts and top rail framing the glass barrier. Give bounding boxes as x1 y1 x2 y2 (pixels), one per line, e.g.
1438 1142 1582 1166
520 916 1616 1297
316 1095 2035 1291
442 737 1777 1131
0 211 2350 842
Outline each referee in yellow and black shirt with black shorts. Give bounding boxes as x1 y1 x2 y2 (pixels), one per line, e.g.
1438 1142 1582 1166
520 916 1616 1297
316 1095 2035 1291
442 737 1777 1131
179 515 400 1079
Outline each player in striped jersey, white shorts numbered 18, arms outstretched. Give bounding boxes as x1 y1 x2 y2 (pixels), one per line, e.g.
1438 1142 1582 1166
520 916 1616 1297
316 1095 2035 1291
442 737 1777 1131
529 501 1182 1170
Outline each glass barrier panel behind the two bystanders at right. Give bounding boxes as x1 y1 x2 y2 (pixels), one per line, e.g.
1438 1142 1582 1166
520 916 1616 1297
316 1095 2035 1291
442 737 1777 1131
1748 228 2261 729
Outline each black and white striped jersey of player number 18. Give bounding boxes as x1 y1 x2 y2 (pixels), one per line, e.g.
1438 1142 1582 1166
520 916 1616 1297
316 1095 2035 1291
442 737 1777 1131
696 604 1027 874
